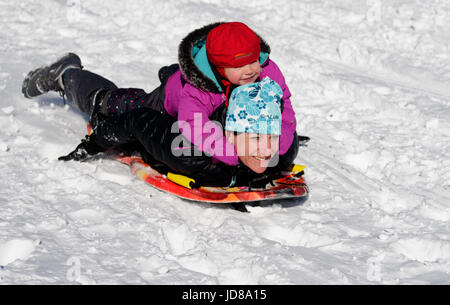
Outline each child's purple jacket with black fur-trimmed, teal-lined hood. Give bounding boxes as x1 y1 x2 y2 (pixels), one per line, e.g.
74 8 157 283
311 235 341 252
164 24 296 165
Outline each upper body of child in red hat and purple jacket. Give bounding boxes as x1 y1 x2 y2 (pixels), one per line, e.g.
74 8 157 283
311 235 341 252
164 22 296 165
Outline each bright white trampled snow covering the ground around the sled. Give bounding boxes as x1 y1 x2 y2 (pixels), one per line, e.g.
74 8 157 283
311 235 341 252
0 0 450 284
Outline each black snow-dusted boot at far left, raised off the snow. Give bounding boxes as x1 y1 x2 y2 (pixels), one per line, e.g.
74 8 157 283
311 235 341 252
22 53 83 98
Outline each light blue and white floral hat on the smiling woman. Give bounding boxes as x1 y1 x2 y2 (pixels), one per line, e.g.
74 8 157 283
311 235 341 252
225 77 283 135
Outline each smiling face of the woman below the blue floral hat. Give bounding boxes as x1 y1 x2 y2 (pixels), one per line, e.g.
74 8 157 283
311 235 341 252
226 131 280 174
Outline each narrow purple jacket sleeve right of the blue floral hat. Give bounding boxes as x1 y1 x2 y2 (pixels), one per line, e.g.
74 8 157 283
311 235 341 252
265 61 297 155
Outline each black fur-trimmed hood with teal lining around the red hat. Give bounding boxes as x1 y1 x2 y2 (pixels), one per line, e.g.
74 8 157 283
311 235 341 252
178 22 270 93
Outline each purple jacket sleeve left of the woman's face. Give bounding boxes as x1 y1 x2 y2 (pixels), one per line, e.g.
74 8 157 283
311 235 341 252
178 84 239 166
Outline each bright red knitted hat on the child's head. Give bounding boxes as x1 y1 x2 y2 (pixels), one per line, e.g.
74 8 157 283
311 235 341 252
206 22 261 68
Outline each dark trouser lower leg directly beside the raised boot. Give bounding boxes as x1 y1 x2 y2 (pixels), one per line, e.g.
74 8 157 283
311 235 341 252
62 69 117 116
